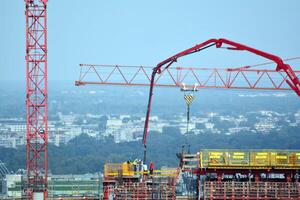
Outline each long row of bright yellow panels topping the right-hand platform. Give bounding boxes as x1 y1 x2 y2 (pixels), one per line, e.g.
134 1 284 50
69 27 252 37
199 149 300 169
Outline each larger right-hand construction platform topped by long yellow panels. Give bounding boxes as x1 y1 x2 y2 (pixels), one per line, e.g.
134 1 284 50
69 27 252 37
181 149 300 200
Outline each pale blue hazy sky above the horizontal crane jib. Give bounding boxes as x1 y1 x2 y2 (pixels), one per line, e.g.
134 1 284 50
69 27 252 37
0 0 300 83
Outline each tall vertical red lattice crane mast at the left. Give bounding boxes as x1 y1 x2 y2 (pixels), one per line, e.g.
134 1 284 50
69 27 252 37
25 0 48 198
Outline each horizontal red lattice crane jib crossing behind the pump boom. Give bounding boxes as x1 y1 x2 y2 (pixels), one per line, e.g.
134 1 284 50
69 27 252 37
75 63 300 90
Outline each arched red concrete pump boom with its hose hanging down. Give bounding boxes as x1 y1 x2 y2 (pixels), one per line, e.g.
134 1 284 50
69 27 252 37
143 38 300 162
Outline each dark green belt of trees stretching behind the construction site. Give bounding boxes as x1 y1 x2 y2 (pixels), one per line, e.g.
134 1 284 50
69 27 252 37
0 127 300 174
